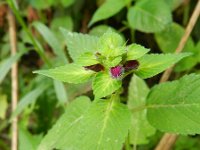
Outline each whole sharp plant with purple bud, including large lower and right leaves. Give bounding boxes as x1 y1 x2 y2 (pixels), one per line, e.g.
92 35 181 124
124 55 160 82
35 29 200 150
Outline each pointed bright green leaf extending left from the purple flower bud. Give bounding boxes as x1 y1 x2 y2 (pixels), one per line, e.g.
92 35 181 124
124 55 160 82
34 63 95 83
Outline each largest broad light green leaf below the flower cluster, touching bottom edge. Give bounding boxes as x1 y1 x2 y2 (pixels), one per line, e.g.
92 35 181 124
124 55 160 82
38 97 130 150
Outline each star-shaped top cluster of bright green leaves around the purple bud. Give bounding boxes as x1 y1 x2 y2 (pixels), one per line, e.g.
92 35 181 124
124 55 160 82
35 29 188 98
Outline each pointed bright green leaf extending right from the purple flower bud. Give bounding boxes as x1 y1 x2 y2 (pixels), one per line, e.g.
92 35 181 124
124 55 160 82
135 53 190 79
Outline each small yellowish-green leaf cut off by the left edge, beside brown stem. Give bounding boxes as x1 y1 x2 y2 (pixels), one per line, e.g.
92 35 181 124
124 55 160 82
0 93 8 119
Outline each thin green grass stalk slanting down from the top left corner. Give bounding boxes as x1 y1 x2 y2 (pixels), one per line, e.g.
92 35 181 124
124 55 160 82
7 0 52 67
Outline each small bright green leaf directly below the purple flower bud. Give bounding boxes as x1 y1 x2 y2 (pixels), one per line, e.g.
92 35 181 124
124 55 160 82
92 73 122 98
